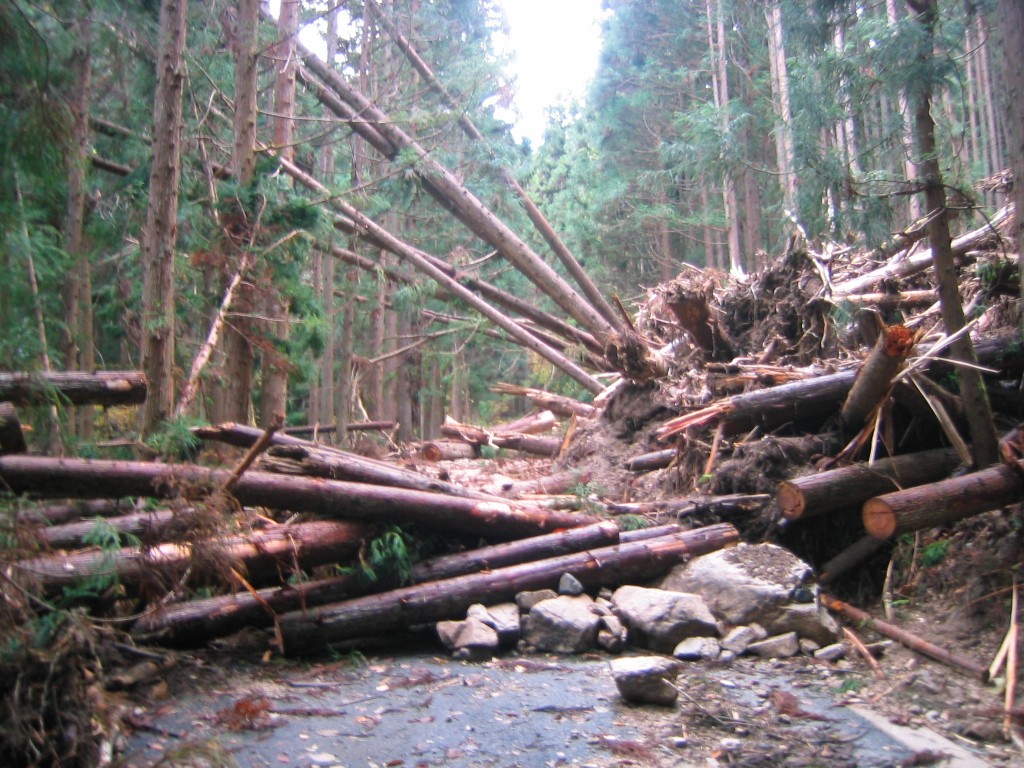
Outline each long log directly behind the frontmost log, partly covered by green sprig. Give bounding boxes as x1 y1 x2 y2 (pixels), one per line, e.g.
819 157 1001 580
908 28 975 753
132 521 620 646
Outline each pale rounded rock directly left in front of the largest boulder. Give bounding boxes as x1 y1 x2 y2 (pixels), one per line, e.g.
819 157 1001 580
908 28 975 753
611 587 719 653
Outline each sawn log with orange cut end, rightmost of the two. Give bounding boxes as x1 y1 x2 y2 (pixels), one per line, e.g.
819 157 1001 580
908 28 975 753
864 460 1024 539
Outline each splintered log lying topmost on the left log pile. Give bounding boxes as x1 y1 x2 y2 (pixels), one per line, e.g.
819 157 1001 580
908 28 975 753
193 423 485 499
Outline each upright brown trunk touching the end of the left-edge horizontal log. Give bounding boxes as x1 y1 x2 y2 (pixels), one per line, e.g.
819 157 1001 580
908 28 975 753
139 0 188 435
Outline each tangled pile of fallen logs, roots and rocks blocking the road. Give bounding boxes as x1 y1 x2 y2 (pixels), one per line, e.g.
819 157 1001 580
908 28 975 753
0 202 1024 765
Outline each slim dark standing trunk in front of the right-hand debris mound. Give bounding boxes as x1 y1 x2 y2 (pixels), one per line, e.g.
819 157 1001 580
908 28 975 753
908 0 998 468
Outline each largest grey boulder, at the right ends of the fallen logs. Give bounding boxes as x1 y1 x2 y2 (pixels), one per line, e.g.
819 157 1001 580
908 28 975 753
657 544 812 626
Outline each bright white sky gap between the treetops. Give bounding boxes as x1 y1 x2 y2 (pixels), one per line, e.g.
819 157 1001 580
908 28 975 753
500 0 604 146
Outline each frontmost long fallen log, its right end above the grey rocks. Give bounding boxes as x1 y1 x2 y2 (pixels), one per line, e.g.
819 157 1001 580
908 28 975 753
280 524 739 654
